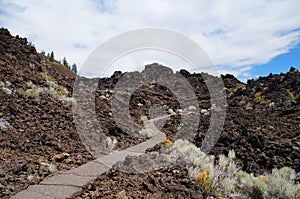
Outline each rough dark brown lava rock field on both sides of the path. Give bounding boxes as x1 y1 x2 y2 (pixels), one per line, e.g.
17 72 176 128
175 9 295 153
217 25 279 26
0 29 300 198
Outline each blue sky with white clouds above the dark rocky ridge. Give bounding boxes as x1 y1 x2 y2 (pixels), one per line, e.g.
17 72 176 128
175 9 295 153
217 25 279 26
0 0 300 81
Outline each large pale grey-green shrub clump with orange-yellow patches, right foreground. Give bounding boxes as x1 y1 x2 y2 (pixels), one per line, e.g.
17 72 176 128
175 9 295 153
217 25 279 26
167 140 300 199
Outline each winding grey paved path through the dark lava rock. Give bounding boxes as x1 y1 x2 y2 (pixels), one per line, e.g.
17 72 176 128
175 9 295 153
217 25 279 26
12 116 168 199
